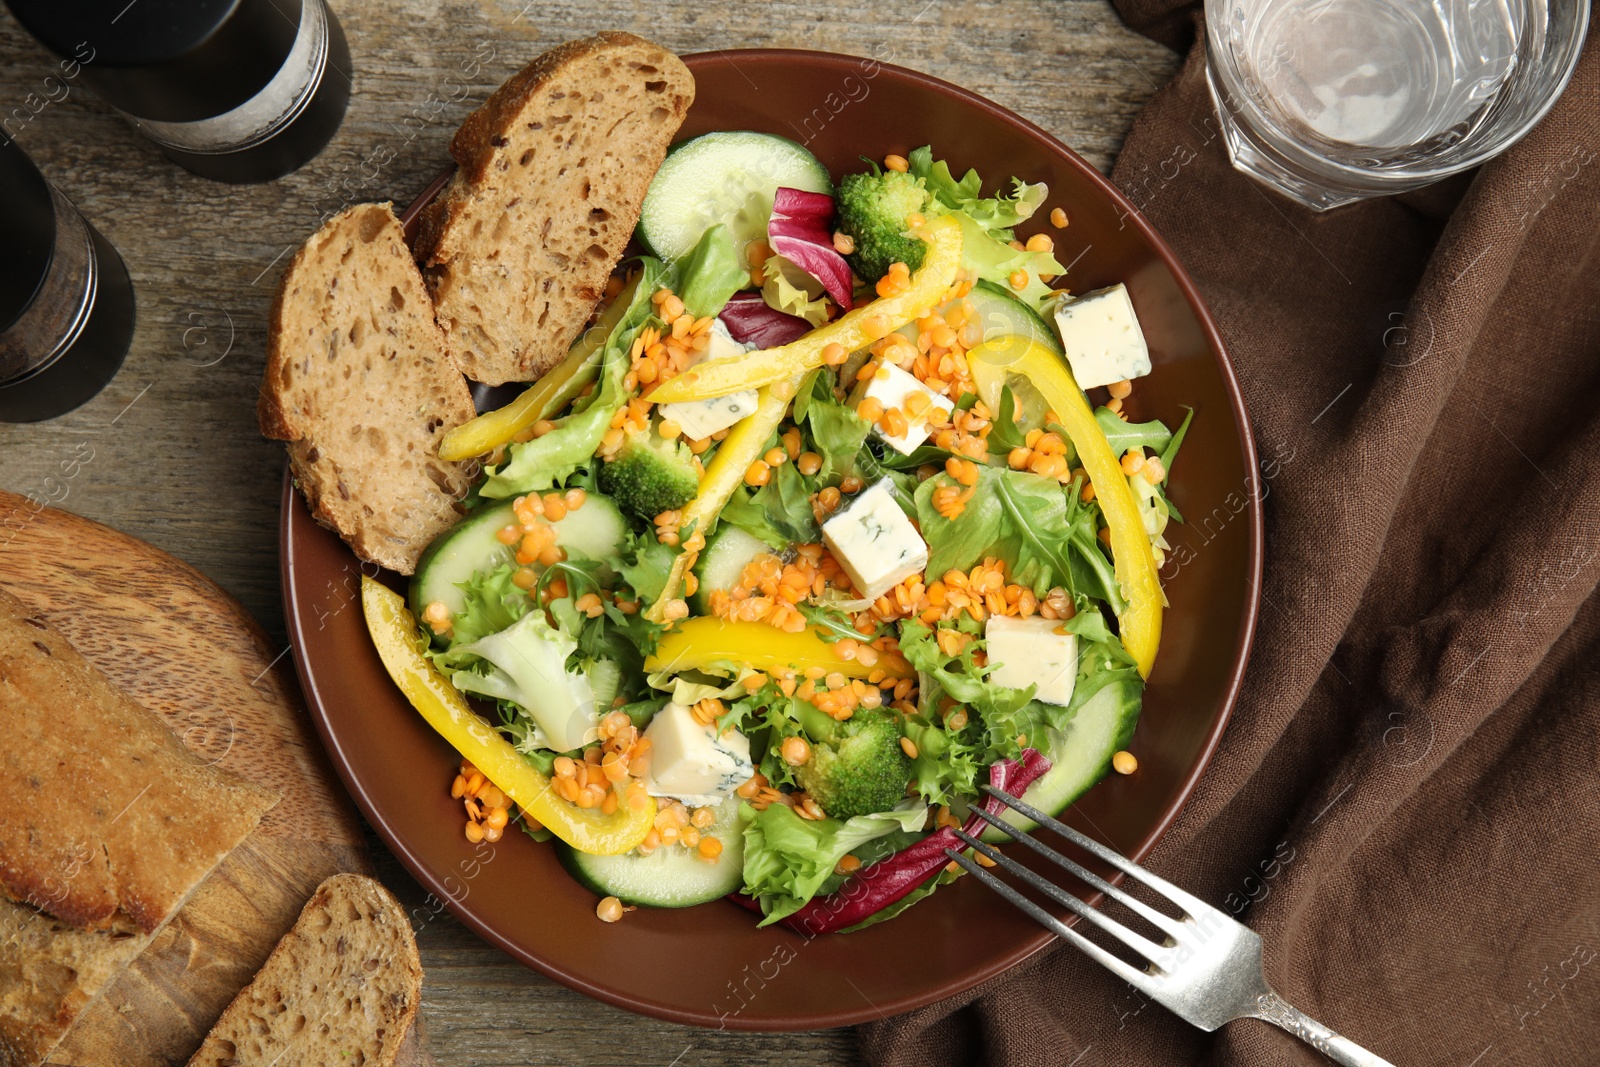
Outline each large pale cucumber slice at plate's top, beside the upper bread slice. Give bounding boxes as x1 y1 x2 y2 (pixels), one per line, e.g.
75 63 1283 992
638 131 834 269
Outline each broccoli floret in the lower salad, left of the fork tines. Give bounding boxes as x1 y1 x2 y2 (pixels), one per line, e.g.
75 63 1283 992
795 709 910 819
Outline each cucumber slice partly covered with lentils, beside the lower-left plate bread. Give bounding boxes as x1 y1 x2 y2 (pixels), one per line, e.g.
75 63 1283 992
411 493 627 616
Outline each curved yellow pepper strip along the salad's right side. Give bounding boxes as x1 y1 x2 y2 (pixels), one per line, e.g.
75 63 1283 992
968 336 1163 678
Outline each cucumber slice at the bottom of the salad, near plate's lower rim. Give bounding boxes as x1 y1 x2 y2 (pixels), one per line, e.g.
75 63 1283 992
555 797 744 907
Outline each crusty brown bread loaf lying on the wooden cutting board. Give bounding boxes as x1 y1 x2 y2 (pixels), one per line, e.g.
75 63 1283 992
0 590 278 1067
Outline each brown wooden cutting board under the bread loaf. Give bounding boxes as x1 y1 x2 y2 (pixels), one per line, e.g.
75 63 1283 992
0 491 426 1067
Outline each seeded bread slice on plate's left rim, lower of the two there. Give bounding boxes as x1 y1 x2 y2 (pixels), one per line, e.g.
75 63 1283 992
258 203 474 574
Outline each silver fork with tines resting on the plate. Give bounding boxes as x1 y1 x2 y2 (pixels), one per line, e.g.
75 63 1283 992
944 785 1394 1067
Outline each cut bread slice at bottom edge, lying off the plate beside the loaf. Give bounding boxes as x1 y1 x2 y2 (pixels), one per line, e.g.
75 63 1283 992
189 875 422 1067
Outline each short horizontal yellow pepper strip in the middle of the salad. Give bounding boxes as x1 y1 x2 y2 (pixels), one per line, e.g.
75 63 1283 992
645 616 915 678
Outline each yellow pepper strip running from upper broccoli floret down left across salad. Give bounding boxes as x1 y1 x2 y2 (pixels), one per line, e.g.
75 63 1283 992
645 216 962 403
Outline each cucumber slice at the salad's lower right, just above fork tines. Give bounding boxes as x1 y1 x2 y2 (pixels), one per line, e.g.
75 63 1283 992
979 681 1144 845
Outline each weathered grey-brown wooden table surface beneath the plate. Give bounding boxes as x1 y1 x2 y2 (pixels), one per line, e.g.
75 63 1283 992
0 0 1176 1067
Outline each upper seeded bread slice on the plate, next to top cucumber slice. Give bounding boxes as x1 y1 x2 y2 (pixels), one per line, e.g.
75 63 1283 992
416 32 694 386
